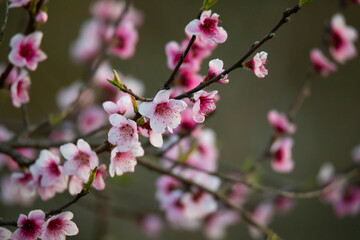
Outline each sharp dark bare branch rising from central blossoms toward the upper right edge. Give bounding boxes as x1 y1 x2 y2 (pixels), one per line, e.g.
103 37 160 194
174 4 300 99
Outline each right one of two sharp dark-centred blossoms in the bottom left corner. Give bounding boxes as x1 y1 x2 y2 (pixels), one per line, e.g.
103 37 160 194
41 211 79 240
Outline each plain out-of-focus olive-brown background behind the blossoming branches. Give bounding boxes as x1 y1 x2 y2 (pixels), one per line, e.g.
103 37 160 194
0 0 360 240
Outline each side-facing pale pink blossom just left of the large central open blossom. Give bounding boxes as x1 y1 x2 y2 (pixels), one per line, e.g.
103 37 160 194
103 95 134 116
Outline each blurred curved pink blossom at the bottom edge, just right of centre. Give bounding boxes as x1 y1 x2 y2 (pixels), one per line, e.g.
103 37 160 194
204 210 240 240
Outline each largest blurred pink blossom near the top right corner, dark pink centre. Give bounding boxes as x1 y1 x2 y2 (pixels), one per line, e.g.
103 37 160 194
330 13 358 64
